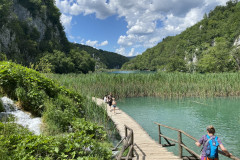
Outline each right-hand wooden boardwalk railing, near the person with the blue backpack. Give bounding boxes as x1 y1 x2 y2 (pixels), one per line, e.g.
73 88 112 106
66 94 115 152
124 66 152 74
155 122 240 160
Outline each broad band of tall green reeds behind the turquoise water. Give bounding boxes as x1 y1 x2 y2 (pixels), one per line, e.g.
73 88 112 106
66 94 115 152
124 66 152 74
47 72 240 98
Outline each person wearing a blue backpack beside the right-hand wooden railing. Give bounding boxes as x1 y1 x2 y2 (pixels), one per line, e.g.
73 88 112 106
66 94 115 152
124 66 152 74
195 126 232 160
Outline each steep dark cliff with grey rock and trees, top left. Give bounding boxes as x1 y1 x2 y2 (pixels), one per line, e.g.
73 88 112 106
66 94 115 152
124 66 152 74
0 0 69 64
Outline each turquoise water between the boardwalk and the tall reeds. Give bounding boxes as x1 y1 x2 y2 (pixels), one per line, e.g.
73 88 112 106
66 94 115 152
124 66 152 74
118 97 240 159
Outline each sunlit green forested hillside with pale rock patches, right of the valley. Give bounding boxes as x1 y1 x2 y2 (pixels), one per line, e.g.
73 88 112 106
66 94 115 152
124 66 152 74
123 0 240 73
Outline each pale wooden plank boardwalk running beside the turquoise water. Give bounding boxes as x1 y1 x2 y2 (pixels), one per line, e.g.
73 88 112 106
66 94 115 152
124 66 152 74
93 98 181 160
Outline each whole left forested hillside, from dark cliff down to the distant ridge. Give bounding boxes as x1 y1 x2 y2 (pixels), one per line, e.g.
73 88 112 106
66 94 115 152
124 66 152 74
0 0 127 73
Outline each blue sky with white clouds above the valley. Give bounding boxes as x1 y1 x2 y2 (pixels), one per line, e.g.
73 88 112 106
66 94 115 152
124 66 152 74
56 0 228 56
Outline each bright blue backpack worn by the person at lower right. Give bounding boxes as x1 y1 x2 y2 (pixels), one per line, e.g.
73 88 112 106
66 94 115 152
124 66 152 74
204 135 219 159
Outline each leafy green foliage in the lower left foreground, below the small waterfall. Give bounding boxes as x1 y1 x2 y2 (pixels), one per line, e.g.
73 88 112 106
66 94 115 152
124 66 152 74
0 119 111 160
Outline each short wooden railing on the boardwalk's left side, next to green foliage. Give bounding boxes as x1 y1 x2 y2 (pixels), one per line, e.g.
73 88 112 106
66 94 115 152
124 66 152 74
113 125 134 160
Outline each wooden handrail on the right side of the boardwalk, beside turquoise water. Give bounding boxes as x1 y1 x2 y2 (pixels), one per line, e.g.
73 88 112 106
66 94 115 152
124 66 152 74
154 122 240 160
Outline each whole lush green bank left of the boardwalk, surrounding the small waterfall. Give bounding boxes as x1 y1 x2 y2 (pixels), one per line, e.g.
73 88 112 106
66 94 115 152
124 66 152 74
0 61 118 160
